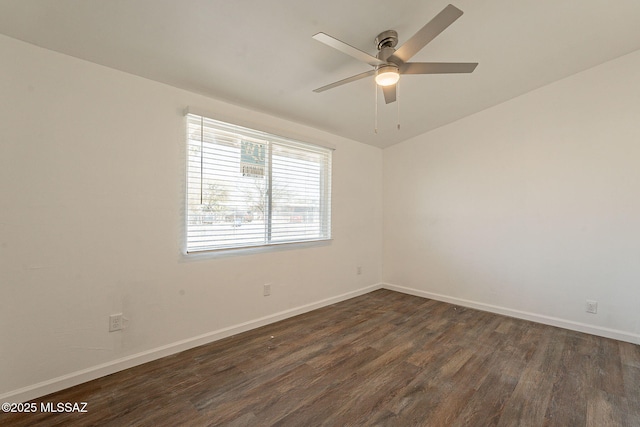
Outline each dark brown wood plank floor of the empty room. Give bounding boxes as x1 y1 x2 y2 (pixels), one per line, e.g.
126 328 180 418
0 290 640 427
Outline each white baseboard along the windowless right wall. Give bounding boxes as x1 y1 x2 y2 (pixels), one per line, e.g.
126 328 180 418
382 283 640 344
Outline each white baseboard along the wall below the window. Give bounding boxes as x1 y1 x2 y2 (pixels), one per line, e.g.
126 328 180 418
0 284 382 403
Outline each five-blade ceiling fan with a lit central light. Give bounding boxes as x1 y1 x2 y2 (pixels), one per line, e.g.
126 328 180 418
313 5 478 104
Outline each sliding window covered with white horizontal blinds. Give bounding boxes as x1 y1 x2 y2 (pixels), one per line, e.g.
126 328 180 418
186 114 332 253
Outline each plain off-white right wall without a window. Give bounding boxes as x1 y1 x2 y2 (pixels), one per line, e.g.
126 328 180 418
383 51 640 343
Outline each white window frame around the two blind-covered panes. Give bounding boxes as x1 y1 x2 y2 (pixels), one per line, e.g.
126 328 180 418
183 109 335 257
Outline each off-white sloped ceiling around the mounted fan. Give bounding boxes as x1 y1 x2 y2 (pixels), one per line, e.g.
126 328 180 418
0 0 640 147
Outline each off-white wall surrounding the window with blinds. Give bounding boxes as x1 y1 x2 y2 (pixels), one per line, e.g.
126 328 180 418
0 36 382 401
